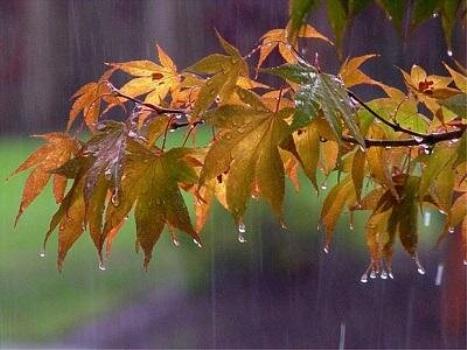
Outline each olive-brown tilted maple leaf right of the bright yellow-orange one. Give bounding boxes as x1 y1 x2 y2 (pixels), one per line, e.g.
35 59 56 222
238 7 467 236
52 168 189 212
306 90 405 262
187 33 248 115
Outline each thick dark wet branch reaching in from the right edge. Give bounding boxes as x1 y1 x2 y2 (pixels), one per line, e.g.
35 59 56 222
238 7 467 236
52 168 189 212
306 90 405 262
342 125 467 148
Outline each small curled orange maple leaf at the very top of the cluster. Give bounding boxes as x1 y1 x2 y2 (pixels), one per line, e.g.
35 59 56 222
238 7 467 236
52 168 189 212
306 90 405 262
257 23 332 69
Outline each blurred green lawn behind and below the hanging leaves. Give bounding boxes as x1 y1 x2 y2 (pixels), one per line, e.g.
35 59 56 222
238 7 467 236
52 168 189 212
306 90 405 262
0 129 446 347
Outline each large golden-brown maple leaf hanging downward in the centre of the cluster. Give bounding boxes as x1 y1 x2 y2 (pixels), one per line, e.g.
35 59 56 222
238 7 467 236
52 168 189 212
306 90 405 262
200 100 292 224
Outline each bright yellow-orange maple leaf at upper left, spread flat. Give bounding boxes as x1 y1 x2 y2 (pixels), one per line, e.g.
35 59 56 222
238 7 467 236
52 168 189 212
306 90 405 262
110 45 182 105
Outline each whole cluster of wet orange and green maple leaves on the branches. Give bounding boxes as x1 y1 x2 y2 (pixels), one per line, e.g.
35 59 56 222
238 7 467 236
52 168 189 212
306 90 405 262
14 2 467 278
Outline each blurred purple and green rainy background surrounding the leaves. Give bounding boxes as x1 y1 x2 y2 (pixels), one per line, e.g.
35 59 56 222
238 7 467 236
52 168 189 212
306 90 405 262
0 0 466 348
